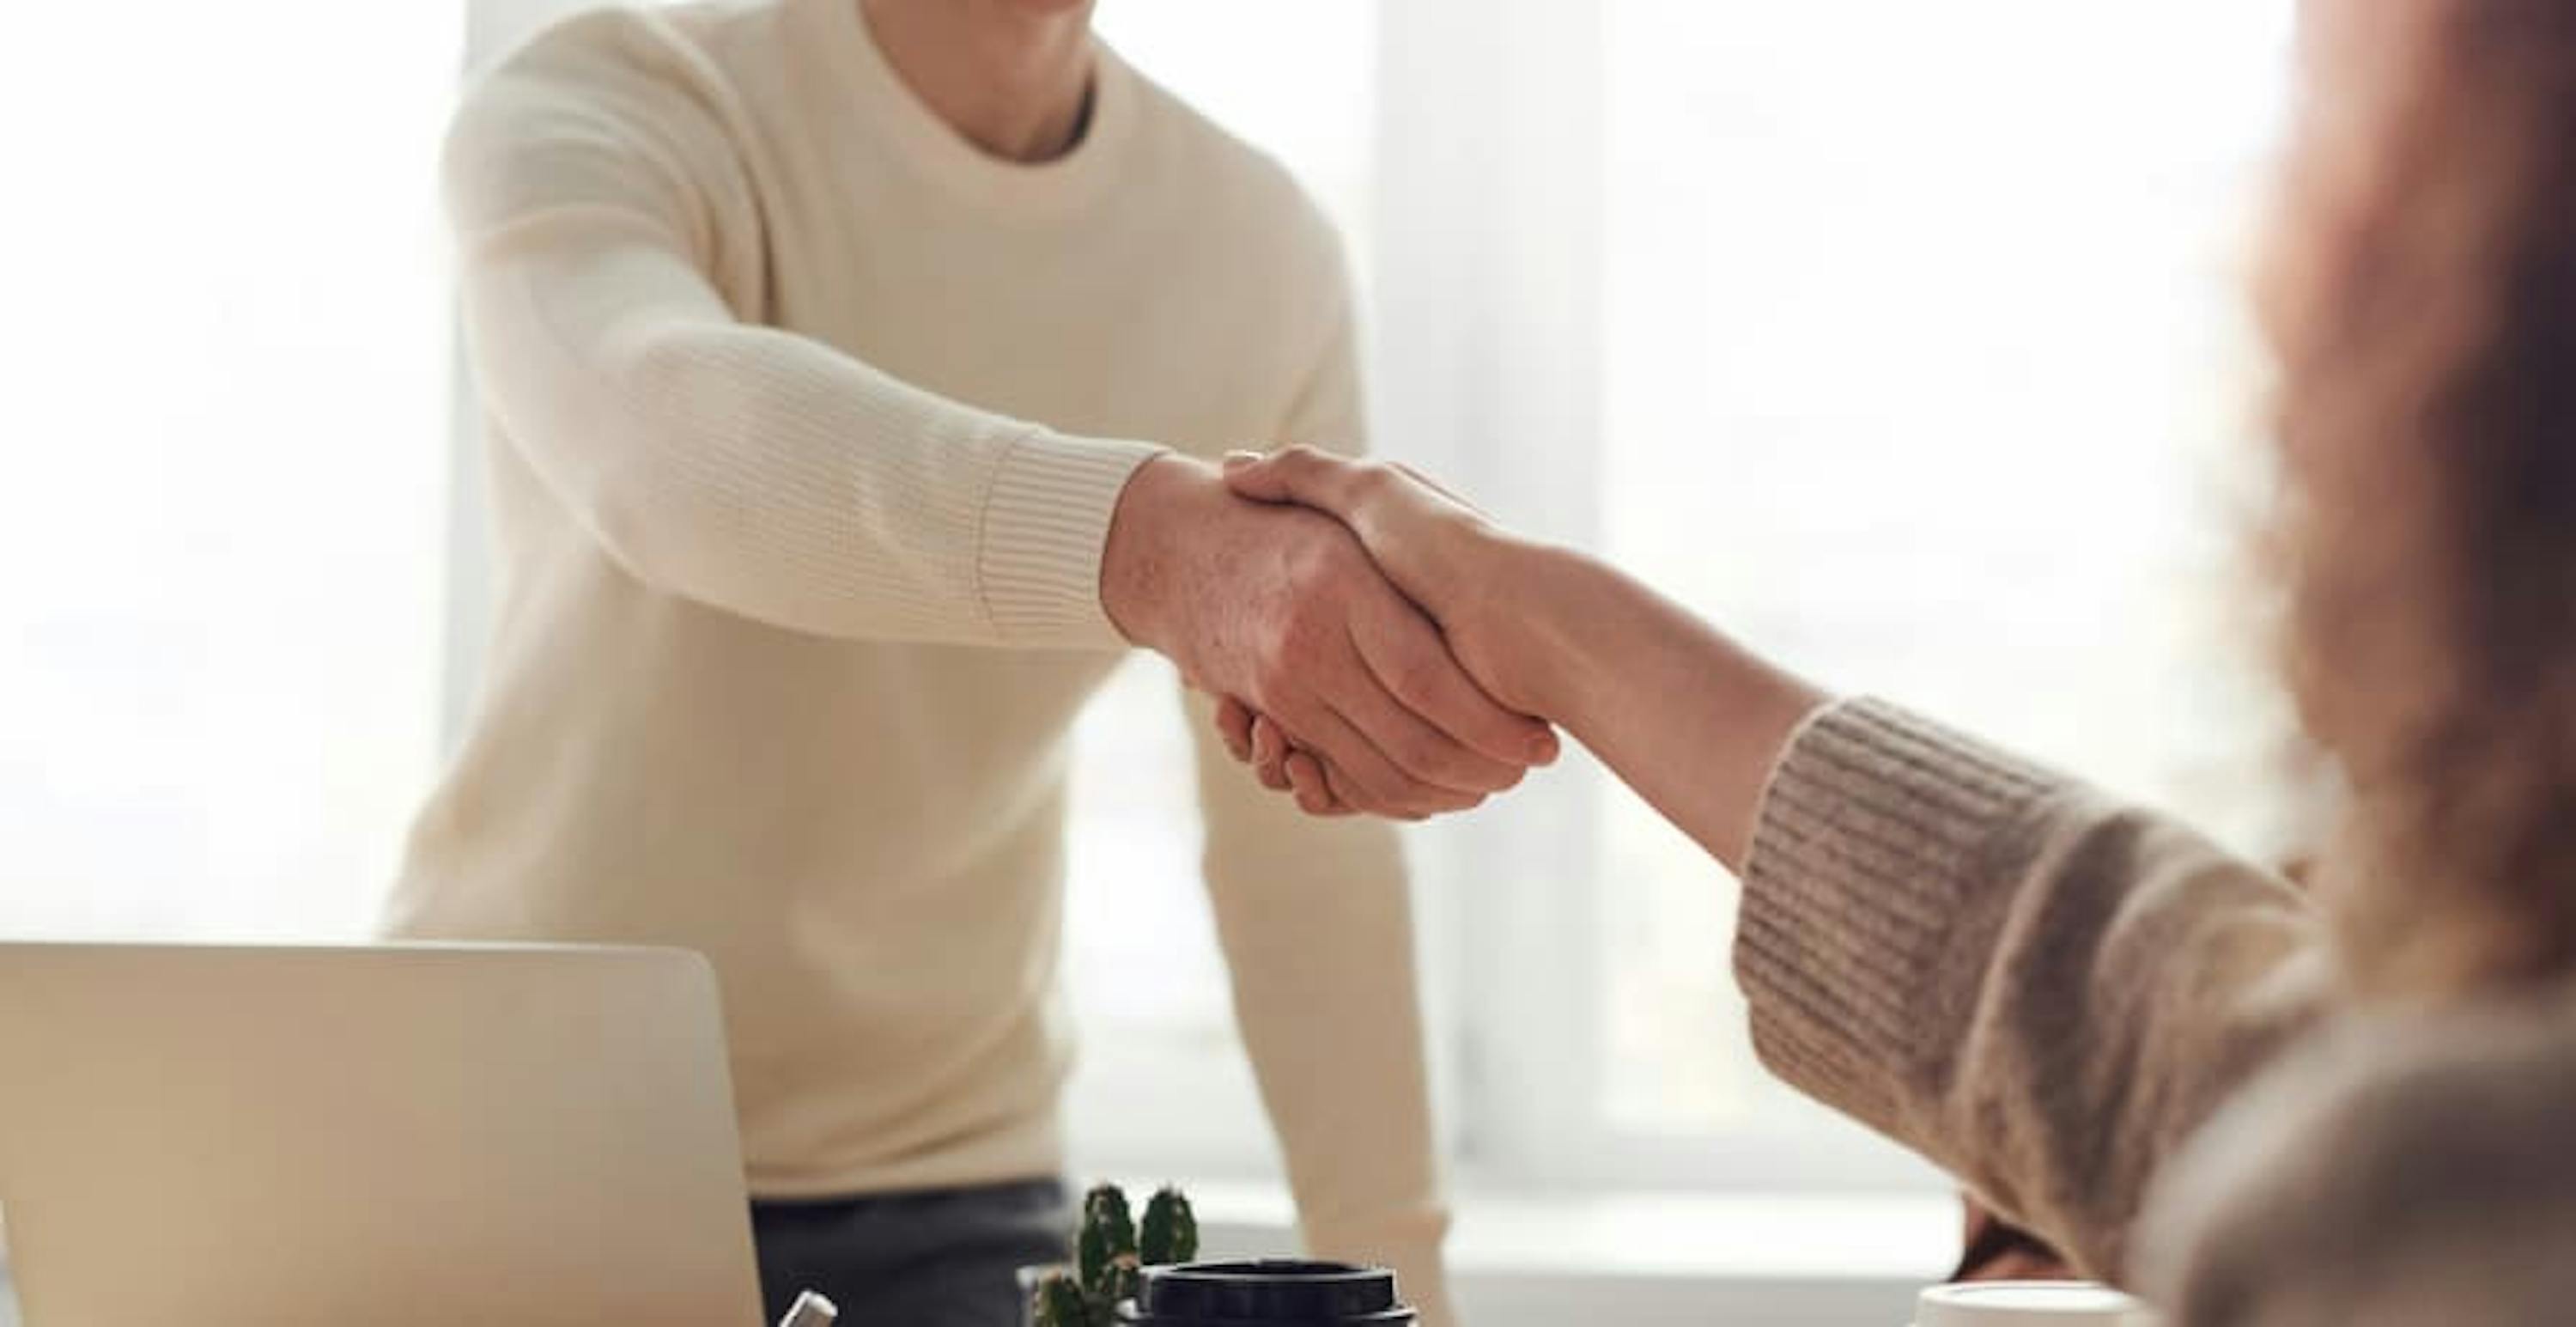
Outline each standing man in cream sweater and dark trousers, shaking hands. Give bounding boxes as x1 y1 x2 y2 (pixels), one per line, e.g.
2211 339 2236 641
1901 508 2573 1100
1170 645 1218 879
389 0 1553 1327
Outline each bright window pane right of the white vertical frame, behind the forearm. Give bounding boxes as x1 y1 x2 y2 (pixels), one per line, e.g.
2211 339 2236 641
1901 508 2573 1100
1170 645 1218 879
1595 0 2290 1160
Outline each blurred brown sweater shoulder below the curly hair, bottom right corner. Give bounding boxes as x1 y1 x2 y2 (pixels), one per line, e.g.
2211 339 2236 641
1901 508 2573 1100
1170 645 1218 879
2143 992 2576 1327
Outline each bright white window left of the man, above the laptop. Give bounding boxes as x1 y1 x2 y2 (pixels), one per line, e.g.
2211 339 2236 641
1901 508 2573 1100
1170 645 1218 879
0 0 464 938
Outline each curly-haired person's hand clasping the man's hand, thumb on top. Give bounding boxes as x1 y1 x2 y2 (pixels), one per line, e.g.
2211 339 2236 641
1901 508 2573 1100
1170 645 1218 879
1216 446 1538 814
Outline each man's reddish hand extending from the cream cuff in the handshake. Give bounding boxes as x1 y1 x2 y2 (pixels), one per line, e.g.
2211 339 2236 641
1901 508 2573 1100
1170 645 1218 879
1100 456 1556 819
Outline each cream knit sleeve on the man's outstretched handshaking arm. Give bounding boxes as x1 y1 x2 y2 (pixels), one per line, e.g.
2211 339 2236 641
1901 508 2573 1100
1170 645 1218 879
446 21 1157 647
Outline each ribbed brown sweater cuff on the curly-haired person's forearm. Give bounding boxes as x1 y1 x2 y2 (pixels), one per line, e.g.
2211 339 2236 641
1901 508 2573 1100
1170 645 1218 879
1734 701 2058 1139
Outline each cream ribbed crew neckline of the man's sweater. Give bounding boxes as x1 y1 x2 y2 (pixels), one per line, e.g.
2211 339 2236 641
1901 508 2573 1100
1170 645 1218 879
796 0 1136 216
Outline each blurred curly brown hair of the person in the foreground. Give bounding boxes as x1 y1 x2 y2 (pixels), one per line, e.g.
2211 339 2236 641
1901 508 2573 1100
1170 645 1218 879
2262 0 2576 995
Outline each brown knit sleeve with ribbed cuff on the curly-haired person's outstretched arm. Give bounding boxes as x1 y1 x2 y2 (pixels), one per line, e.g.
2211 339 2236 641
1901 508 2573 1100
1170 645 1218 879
1736 701 2326 1281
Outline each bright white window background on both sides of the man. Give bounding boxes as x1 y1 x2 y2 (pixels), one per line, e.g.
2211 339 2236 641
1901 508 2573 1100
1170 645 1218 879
0 0 2293 1319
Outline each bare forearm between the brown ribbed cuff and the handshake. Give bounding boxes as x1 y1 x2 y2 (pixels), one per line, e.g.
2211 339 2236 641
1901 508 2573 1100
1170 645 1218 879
1499 546 1826 871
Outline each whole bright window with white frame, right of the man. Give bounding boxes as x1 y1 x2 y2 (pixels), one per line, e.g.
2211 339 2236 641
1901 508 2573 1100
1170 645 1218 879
1072 0 2290 1188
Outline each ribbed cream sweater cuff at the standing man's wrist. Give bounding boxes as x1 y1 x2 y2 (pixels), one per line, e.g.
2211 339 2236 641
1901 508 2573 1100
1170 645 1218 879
976 428 1164 647
